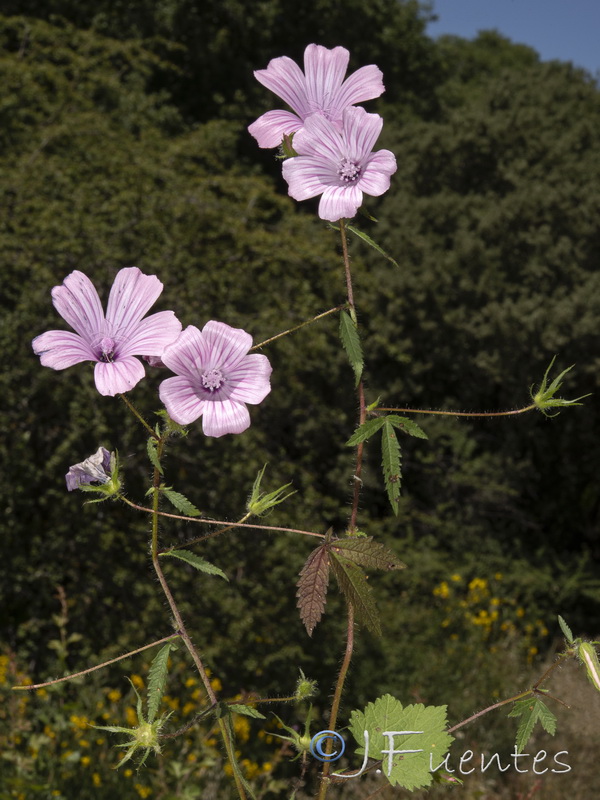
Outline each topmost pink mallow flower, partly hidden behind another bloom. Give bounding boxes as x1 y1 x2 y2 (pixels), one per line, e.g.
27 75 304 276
248 44 384 147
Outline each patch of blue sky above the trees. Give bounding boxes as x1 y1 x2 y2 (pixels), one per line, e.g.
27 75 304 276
427 0 600 75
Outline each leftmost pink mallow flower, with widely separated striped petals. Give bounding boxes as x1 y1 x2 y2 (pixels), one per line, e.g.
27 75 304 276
31 267 181 396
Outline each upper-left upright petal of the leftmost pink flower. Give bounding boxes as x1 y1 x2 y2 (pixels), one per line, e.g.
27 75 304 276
52 270 105 342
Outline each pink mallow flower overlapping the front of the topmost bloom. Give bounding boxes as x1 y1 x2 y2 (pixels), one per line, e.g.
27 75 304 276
283 107 397 222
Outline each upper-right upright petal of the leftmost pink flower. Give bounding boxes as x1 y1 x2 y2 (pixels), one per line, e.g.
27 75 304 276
106 267 163 344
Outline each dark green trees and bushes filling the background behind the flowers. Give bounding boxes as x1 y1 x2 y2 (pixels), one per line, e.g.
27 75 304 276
0 0 600 788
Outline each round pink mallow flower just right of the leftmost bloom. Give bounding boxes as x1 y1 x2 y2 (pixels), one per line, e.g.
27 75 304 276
159 320 272 436
